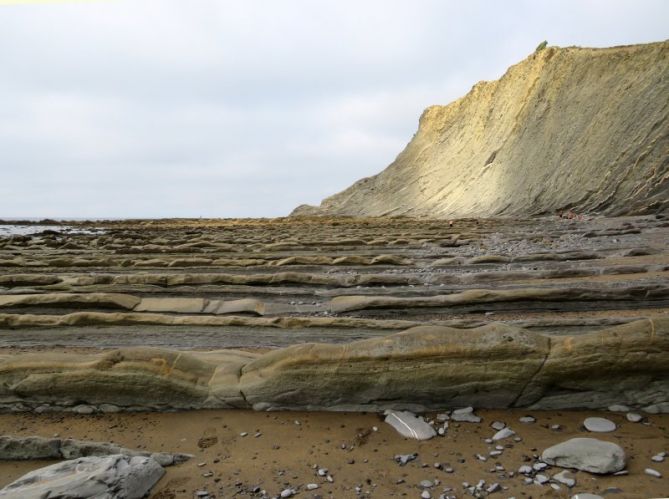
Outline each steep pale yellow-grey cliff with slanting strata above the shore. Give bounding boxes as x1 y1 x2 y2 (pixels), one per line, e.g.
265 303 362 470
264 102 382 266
293 41 669 217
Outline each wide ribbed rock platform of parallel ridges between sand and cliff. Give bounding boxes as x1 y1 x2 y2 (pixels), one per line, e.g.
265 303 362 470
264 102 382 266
0 215 669 413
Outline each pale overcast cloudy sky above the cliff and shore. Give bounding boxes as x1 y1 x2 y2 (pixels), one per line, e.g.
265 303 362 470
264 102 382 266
0 0 669 218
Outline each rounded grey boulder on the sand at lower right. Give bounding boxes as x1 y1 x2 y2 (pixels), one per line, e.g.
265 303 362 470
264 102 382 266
541 438 625 474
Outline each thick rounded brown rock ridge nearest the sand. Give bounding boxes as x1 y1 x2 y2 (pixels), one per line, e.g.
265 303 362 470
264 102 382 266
0 319 669 412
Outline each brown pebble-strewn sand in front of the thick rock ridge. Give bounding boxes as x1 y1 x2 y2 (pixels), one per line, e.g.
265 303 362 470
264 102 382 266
0 410 669 499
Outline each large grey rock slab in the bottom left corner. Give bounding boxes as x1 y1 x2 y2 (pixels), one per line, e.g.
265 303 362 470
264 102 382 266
0 455 165 499
